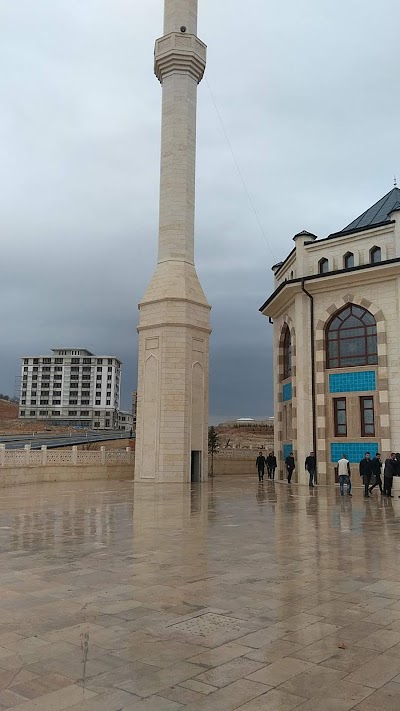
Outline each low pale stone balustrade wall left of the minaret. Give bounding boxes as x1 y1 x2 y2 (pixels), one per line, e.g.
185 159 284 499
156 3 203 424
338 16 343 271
0 444 134 469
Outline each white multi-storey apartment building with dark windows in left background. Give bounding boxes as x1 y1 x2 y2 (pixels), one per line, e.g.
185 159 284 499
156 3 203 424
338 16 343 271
19 348 121 429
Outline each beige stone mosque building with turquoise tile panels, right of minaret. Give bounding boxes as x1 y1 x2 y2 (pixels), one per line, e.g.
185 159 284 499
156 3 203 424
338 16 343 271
261 188 400 483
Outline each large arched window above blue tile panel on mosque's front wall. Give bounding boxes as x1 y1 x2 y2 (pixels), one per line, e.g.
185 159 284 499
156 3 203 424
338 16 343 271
326 304 378 368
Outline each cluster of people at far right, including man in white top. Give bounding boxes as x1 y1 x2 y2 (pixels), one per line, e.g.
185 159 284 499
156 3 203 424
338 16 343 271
338 452 400 499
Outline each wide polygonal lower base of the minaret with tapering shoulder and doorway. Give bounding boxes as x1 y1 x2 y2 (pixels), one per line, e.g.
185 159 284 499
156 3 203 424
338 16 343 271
135 263 210 483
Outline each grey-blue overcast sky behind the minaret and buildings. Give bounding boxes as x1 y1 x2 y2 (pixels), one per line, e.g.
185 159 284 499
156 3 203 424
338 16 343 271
0 0 400 421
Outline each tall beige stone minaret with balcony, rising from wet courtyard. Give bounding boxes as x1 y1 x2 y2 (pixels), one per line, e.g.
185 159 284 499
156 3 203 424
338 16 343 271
135 0 211 482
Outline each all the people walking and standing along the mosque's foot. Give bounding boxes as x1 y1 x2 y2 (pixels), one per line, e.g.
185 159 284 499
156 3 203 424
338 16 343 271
256 451 400 499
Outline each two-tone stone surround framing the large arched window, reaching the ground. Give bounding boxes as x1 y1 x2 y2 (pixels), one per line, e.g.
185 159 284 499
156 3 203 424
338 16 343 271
315 294 391 482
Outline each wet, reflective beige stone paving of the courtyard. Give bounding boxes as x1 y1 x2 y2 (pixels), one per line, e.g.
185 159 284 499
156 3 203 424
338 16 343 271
0 478 400 711
